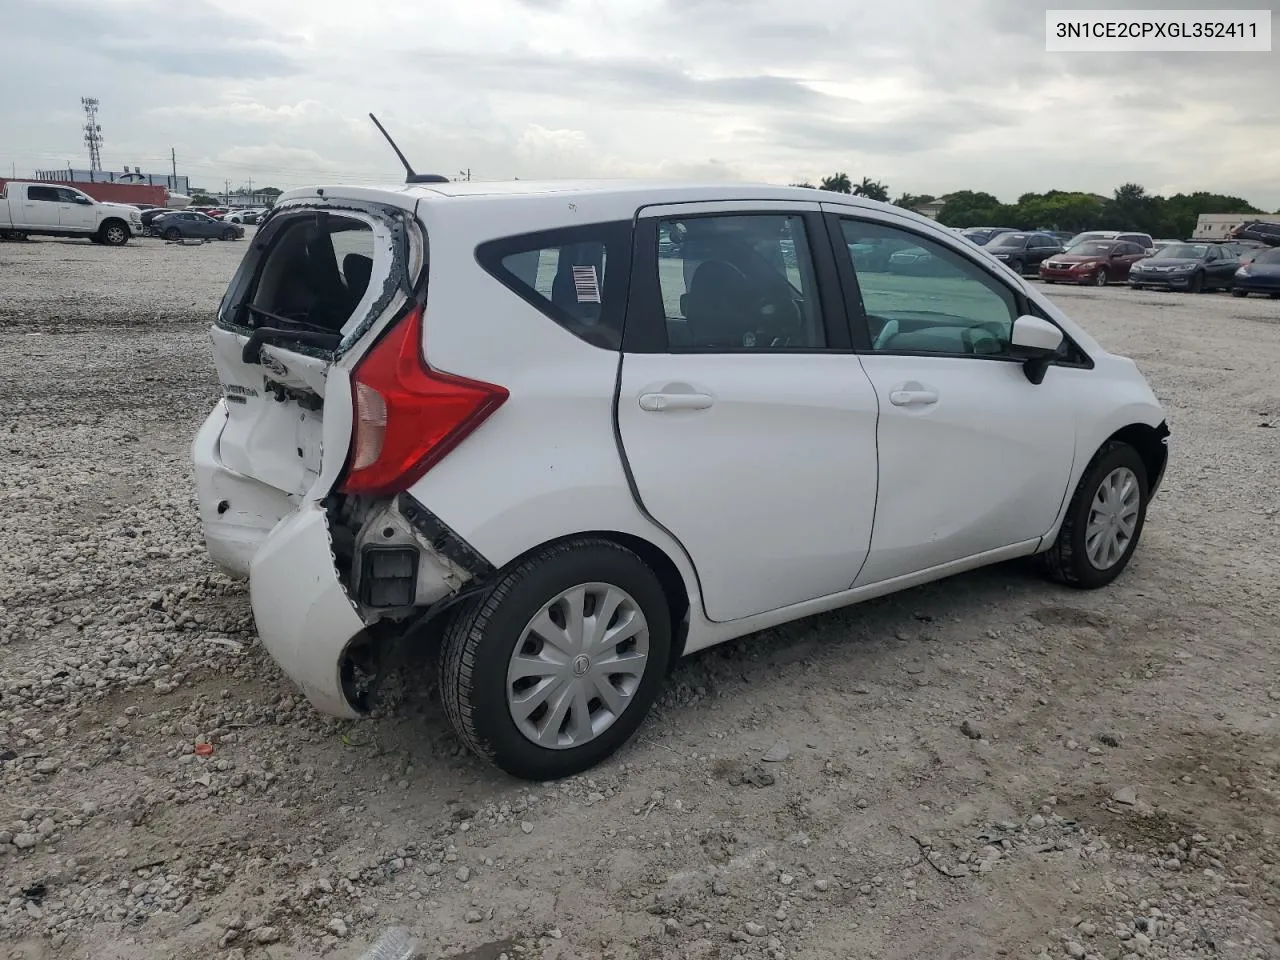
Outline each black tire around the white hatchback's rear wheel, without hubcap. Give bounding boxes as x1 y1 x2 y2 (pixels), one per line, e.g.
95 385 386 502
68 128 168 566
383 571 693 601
440 538 671 781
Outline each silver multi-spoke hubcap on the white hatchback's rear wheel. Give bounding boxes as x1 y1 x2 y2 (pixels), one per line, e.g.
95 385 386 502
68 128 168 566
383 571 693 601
507 584 649 750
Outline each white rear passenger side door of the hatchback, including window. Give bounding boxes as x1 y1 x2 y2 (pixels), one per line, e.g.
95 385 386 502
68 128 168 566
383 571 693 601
617 202 876 621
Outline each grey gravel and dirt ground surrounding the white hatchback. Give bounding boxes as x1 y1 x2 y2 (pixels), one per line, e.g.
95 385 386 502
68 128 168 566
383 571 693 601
0 241 1280 960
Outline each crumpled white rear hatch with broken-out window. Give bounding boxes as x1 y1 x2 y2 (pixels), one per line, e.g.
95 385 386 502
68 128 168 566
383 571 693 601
211 201 424 498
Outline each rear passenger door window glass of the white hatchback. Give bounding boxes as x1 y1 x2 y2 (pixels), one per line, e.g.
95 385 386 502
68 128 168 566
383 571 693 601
658 214 827 351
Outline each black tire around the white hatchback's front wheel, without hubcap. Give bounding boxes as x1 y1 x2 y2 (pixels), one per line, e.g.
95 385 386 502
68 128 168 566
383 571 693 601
1041 440 1151 590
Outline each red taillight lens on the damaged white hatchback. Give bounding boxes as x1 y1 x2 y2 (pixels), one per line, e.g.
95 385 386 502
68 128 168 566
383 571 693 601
342 307 508 497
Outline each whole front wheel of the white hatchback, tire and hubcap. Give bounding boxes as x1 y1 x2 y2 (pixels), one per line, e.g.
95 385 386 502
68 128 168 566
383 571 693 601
1042 440 1149 590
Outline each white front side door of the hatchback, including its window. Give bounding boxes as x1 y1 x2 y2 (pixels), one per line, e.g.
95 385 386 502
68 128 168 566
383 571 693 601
832 206 1080 586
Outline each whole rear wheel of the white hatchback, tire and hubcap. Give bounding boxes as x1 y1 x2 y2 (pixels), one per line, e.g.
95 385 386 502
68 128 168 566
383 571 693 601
440 538 671 780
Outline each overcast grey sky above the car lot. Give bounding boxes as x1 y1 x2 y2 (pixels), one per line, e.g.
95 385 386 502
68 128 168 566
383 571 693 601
0 0 1280 210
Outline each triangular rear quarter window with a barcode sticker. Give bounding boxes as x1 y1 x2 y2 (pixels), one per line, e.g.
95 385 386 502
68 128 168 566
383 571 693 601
476 221 631 349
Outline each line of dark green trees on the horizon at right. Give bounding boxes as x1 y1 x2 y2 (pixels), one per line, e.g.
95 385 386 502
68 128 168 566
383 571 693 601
791 173 1264 244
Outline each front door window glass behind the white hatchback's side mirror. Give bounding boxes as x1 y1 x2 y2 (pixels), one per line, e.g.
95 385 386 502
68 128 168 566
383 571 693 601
841 219 1018 356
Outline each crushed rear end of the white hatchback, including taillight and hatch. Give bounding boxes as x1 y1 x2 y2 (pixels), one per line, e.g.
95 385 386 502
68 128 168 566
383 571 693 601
192 188 507 717
